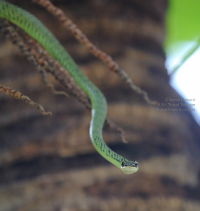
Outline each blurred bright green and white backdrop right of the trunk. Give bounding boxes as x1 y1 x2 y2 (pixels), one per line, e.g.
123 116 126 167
163 0 200 125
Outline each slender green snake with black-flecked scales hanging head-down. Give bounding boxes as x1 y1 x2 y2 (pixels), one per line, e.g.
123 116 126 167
0 0 138 174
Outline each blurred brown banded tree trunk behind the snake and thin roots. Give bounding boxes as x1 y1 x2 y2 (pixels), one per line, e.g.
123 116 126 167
0 0 200 211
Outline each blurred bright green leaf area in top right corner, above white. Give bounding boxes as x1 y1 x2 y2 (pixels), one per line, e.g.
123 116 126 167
164 0 200 50
